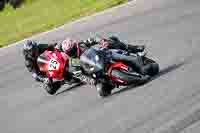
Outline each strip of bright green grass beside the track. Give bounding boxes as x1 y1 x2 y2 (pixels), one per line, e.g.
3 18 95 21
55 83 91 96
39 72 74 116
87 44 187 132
0 0 128 47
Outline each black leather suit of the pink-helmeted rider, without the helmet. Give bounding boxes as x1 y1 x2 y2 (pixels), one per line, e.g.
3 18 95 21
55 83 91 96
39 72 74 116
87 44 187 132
56 37 148 75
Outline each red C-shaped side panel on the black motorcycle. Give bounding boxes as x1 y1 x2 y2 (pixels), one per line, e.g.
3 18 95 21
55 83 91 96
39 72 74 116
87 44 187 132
108 62 128 84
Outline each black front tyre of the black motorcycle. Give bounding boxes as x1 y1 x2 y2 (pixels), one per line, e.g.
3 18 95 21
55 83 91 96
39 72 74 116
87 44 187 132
96 83 114 97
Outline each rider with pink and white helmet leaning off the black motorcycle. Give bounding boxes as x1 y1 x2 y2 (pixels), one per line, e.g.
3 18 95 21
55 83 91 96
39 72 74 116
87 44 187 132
56 36 150 75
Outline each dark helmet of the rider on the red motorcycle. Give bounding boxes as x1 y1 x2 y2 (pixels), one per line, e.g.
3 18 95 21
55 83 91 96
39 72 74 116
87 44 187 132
23 40 37 57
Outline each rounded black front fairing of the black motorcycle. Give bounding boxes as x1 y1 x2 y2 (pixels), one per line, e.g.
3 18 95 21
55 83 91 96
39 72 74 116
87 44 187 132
80 48 106 75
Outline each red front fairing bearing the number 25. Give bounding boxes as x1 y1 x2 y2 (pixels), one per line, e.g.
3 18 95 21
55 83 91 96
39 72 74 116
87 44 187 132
38 50 68 80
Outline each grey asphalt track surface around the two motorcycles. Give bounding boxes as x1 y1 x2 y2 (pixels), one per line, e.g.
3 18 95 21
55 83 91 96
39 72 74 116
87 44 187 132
0 0 200 133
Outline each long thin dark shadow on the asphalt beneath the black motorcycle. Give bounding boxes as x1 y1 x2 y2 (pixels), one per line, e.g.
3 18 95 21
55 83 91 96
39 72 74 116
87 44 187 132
110 61 188 96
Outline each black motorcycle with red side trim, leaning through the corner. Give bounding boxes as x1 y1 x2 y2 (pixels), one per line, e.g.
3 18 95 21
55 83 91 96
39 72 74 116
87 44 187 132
80 47 159 97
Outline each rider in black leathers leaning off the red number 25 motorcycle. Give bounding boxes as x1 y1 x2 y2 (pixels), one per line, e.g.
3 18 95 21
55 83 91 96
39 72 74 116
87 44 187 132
23 40 76 94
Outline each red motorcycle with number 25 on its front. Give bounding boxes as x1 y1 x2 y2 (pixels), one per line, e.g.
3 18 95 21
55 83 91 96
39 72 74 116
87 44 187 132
37 50 79 95
